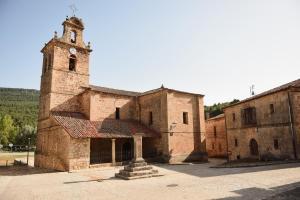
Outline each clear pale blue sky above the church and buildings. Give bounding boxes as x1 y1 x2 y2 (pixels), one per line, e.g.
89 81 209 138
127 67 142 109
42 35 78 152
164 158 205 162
0 0 300 105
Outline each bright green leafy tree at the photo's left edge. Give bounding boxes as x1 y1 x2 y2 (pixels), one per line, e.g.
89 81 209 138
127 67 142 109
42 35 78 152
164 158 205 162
0 115 17 145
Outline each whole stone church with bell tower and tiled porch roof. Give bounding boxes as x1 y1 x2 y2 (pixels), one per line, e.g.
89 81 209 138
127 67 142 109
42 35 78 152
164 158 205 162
35 17 206 171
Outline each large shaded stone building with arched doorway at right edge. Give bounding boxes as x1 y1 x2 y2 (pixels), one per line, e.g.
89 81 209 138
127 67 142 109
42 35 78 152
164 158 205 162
224 79 300 160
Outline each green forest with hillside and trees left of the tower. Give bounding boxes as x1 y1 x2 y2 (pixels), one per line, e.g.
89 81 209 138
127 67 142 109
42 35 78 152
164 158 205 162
0 88 39 145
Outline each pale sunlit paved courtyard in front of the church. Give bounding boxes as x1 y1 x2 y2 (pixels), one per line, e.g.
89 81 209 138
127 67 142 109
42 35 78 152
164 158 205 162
0 160 300 200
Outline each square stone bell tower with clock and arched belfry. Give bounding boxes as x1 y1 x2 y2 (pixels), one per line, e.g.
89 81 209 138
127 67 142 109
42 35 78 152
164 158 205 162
39 16 92 121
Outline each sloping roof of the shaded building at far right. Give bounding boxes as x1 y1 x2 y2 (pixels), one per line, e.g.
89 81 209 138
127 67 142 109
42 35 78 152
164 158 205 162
224 79 300 109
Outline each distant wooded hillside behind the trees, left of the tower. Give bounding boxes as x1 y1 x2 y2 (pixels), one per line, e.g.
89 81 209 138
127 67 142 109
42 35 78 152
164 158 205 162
0 88 39 127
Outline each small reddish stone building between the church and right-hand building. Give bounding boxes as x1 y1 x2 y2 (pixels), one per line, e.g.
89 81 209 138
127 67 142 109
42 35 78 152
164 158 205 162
205 114 227 157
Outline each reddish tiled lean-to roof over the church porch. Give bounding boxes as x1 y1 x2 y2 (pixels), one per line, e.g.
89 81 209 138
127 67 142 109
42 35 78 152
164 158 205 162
51 111 160 138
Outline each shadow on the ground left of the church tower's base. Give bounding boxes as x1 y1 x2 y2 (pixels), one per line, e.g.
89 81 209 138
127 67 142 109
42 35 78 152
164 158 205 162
0 165 58 176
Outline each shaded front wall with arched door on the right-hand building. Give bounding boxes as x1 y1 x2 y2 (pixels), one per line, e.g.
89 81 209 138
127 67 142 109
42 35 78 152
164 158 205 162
225 91 294 160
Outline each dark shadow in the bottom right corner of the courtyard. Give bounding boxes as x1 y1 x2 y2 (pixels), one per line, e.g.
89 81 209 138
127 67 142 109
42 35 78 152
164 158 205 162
218 182 300 200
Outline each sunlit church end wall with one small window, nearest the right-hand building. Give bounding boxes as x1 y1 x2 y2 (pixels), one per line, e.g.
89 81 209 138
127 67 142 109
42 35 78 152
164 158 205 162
167 92 205 162
